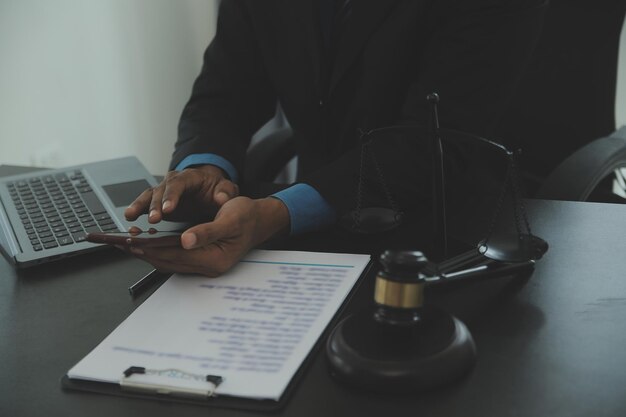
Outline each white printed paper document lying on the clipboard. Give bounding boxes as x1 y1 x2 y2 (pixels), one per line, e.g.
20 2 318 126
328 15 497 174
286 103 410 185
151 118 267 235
67 250 370 400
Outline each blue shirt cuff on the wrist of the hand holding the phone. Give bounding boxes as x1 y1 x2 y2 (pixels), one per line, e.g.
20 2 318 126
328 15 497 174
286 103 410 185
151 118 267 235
272 184 336 235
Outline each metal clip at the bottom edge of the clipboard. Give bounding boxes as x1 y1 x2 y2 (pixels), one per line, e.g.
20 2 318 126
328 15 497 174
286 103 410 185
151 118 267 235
120 366 224 399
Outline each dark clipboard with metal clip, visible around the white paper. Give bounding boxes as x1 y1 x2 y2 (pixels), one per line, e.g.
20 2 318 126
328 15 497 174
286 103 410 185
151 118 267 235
60 252 372 412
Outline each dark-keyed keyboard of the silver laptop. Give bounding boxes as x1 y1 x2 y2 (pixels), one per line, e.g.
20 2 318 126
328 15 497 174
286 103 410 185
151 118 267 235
7 171 119 251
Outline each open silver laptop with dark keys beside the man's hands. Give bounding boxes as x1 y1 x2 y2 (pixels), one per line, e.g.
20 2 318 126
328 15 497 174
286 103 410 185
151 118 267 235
0 157 176 268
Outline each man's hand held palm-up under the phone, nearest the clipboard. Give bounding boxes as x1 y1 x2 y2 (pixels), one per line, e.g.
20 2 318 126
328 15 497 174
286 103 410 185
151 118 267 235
124 197 289 277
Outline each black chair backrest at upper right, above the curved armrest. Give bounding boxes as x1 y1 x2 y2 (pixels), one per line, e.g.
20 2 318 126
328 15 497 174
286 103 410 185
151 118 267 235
494 0 626 195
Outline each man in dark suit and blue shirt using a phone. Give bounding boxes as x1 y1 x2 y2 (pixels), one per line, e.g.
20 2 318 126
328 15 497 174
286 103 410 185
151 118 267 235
126 0 545 276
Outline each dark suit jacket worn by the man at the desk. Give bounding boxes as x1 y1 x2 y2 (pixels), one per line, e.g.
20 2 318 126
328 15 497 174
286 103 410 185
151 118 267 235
172 0 545 224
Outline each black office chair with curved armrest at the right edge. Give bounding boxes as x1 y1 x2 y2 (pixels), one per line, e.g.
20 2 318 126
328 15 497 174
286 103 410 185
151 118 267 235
492 0 626 202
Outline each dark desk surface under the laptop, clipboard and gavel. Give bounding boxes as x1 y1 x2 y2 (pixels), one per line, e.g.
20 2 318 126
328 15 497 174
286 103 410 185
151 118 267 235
0 164 626 417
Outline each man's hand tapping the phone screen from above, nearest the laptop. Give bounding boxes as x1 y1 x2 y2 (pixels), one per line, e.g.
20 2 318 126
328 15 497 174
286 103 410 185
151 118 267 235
124 165 239 223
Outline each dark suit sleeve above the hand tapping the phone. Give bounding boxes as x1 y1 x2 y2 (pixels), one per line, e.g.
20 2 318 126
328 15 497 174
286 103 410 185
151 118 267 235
170 0 276 173
